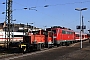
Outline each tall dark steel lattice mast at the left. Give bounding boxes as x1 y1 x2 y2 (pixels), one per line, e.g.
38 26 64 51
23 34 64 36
6 0 12 48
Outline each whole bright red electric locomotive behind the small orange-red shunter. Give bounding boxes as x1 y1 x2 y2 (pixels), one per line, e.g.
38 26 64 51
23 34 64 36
47 26 75 46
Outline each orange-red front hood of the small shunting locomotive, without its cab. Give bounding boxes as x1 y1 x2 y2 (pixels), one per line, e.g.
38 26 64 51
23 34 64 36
23 31 45 44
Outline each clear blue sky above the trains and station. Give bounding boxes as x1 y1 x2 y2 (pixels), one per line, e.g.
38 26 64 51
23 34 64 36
0 0 90 31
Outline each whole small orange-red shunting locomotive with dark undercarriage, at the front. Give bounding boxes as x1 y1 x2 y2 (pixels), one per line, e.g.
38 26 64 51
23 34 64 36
10 30 53 52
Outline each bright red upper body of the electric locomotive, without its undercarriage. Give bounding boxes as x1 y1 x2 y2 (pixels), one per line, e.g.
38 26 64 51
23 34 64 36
47 28 75 44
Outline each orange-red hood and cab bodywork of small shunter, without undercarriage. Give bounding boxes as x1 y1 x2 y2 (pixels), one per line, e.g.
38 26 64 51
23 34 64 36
23 30 53 44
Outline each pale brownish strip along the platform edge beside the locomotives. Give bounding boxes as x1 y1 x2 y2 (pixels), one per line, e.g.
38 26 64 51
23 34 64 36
0 40 88 59
